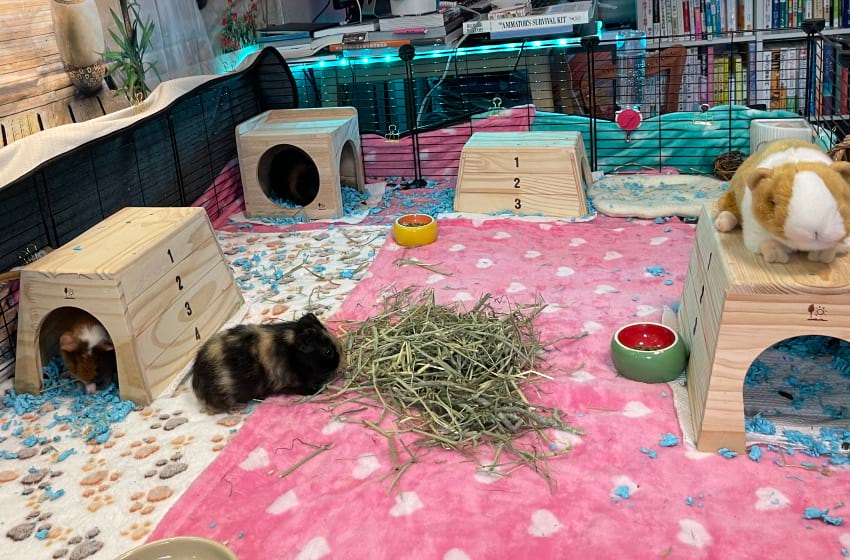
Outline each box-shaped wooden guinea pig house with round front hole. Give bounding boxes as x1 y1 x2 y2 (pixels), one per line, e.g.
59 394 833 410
236 107 366 219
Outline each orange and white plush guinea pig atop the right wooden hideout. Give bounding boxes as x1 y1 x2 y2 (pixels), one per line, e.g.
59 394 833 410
714 139 850 263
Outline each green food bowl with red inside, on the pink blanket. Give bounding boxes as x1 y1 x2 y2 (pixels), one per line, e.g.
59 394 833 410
611 322 688 383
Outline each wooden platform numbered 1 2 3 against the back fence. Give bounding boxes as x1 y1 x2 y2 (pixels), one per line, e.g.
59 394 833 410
454 132 593 218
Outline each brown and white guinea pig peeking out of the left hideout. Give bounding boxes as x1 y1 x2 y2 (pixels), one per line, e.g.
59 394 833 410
59 310 116 394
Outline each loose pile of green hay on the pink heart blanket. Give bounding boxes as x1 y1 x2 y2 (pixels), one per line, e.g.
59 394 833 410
324 290 583 488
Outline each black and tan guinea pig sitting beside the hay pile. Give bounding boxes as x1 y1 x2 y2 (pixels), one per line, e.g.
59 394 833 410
192 313 345 411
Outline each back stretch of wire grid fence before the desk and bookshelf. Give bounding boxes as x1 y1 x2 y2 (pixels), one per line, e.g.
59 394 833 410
293 31 813 179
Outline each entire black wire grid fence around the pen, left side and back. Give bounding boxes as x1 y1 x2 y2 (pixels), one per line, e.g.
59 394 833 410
0 26 850 379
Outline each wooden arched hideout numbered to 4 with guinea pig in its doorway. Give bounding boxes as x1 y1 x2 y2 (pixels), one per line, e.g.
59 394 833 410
15 207 243 404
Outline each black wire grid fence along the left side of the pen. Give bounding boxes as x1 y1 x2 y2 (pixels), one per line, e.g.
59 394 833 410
0 49 298 379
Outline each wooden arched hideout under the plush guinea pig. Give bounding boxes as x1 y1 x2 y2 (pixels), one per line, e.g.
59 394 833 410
678 207 850 453
